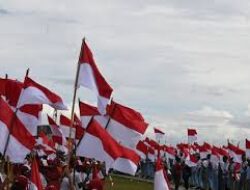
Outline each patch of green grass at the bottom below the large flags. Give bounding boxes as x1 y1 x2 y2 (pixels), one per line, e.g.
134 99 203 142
105 176 153 190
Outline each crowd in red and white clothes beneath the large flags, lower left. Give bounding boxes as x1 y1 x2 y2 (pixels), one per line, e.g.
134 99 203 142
0 151 106 190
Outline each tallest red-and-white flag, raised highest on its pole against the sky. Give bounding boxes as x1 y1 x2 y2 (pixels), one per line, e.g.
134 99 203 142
77 41 113 114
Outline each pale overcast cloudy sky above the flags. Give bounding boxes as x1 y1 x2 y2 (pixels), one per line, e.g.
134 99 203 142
0 0 250 146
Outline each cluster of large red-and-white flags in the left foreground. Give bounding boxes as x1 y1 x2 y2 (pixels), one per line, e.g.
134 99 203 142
0 40 172 189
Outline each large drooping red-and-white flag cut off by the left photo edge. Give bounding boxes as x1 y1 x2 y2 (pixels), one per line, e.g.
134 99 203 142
0 97 36 163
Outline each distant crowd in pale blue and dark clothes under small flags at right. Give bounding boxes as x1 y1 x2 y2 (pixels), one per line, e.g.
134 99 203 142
140 154 250 190
